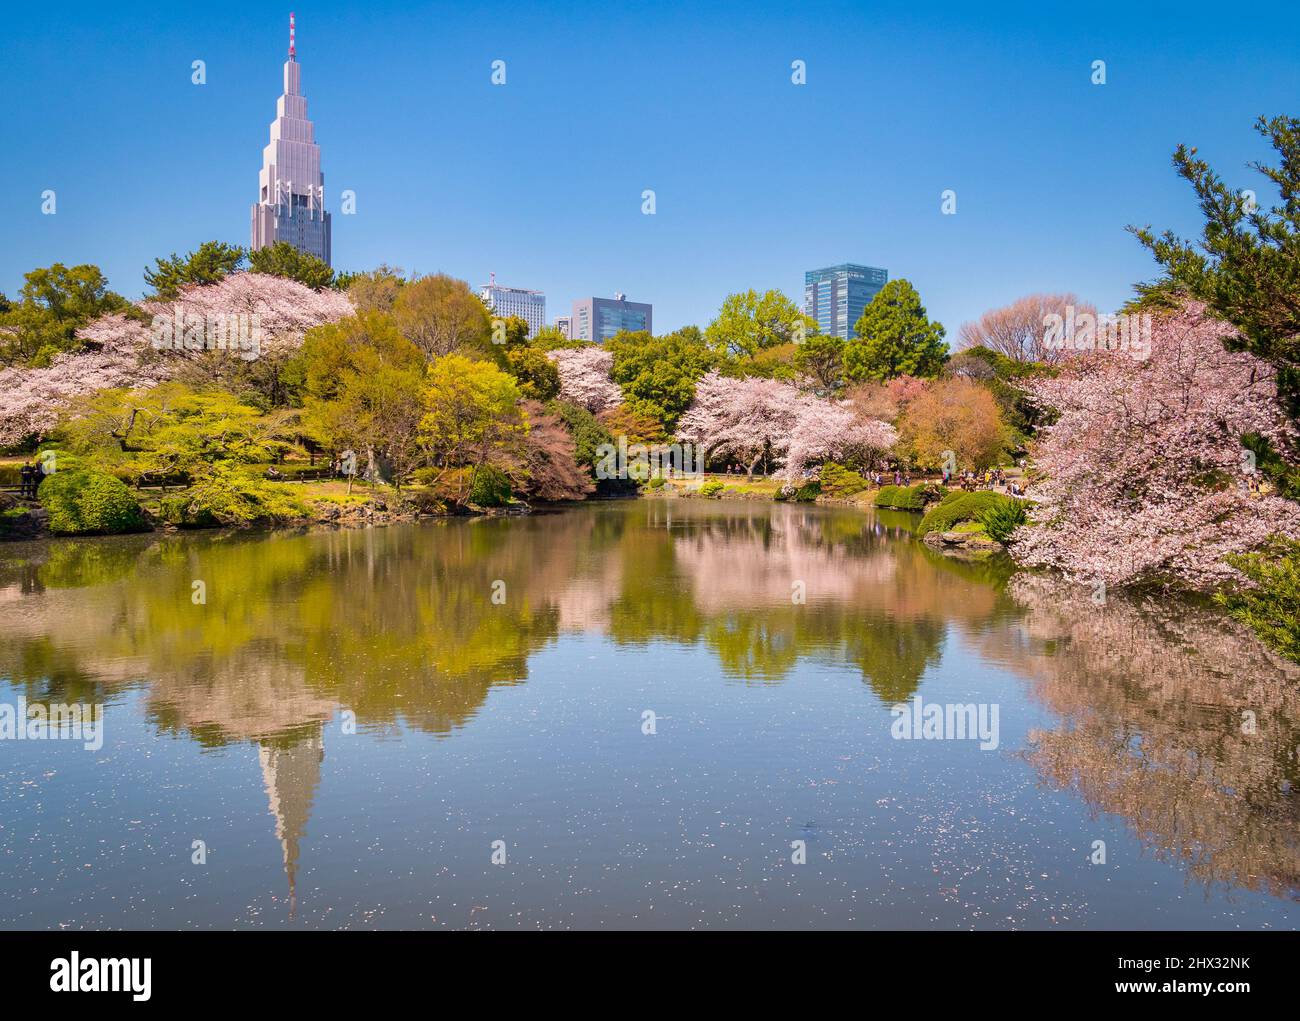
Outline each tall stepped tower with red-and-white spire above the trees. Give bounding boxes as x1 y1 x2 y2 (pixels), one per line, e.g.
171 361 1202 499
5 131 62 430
252 14 330 263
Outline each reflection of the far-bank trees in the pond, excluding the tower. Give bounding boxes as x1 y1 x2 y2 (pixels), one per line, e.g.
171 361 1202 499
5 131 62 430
0 501 1002 745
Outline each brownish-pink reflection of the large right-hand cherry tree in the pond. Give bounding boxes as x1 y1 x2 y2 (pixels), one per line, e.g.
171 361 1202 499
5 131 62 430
1008 574 1300 899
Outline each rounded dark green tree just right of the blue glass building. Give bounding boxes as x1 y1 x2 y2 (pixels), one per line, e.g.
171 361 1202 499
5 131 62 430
844 280 948 381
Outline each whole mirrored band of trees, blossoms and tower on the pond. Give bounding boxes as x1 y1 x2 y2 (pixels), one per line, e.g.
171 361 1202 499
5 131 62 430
0 499 1300 904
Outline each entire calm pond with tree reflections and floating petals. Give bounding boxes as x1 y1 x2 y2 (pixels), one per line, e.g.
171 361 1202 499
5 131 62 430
0 498 1300 929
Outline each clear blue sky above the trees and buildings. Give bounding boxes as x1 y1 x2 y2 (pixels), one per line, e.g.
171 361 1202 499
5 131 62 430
0 0 1300 339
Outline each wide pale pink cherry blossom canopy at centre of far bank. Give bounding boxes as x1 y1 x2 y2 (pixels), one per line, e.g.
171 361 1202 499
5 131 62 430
677 371 897 480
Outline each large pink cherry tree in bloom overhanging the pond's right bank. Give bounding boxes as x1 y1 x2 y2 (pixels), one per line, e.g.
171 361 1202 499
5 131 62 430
1014 304 1300 587
